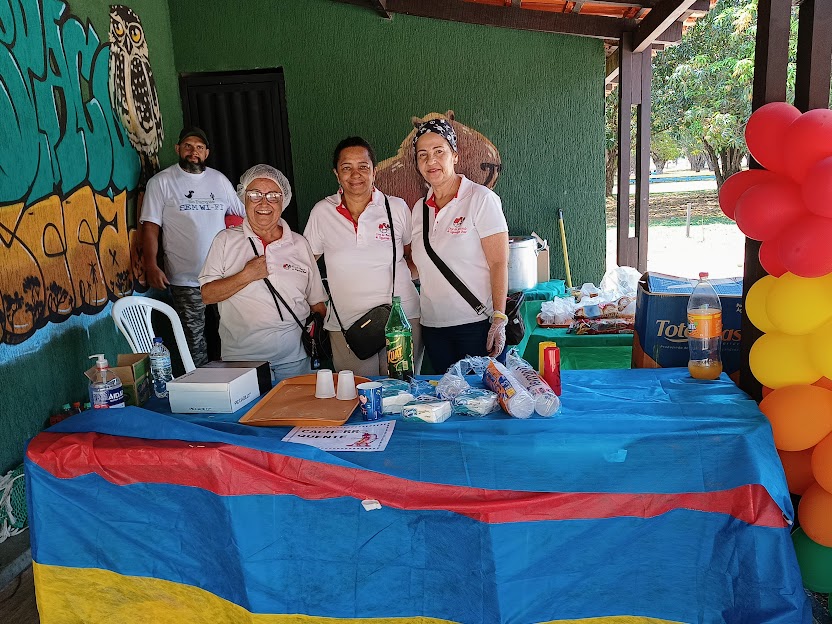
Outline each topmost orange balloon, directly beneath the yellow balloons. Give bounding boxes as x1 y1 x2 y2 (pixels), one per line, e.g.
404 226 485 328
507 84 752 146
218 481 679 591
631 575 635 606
760 386 832 448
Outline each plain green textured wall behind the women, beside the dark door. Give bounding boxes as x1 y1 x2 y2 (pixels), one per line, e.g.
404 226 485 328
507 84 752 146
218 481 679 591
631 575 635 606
170 0 606 285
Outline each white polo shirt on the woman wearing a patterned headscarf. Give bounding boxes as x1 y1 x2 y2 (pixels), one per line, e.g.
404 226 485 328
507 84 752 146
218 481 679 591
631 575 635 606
411 176 508 327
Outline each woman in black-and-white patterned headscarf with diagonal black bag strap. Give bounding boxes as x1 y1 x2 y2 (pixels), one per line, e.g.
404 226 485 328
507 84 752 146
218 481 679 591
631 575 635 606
413 119 508 373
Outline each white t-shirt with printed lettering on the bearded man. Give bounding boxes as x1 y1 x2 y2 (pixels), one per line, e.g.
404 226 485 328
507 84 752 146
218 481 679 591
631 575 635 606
139 164 246 286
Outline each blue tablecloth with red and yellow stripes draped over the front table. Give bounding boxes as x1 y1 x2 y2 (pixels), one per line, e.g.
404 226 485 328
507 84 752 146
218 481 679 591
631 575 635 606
26 369 811 624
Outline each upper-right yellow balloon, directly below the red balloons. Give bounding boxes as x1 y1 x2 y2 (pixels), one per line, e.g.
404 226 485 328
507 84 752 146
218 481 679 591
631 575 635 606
772 273 832 335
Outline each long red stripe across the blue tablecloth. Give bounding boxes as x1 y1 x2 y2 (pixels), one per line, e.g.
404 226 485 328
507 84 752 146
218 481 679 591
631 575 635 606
27 432 787 528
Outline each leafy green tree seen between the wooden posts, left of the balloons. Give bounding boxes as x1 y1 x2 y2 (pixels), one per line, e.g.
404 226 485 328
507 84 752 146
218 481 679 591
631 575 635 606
652 0 757 187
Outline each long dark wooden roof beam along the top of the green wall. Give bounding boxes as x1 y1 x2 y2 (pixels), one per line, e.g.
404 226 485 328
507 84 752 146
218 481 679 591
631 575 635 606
386 0 632 39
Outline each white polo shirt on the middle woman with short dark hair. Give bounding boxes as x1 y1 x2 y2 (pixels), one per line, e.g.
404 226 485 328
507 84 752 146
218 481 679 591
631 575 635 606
303 189 419 331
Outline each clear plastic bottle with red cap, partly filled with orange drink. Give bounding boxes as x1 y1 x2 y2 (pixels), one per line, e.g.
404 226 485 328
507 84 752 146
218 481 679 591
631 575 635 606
688 272 722 379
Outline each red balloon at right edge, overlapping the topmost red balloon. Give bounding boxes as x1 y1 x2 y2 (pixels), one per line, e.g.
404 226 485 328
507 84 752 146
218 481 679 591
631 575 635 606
783 108 832 183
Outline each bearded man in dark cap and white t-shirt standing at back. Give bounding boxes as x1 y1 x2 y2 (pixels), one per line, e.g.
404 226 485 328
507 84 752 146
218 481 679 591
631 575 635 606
139 127 245 366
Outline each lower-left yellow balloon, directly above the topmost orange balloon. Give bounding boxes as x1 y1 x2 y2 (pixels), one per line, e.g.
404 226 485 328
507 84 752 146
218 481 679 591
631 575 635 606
748 332 822 388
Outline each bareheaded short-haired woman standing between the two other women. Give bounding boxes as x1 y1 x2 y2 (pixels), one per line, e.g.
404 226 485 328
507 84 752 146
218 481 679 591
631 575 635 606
303 137 422 377
